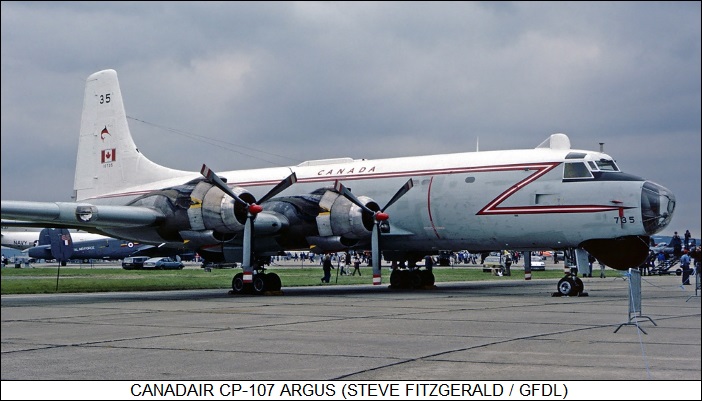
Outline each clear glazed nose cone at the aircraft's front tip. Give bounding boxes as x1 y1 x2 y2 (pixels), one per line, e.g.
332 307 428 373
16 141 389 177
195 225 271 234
641 181 675 235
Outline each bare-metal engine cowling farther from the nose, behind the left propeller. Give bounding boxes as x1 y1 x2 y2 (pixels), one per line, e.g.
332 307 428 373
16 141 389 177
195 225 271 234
188 181 256 233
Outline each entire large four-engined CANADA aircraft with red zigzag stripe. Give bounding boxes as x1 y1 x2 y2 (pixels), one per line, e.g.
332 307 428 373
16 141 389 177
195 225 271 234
2 70 675 293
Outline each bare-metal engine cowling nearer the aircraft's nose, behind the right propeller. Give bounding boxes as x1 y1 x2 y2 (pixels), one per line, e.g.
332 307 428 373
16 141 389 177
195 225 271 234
317 191 380 239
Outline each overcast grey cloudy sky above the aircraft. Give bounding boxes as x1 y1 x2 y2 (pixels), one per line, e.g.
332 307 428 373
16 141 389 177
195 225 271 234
0 1 702 238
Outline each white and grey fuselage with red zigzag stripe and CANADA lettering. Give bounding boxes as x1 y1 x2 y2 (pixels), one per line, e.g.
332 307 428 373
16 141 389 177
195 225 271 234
86 145 656 253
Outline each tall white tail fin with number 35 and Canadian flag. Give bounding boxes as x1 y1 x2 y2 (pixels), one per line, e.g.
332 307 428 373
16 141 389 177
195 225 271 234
73 70 191 201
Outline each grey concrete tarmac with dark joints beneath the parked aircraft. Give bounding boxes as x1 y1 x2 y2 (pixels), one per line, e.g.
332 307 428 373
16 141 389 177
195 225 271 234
1 265 702 381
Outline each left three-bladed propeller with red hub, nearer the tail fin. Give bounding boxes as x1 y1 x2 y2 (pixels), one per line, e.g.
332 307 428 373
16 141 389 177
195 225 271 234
200 164 297 283
